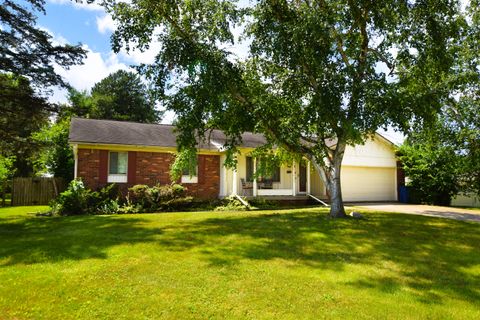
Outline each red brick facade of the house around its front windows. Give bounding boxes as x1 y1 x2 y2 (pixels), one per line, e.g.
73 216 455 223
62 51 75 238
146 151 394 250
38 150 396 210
77 149 220 199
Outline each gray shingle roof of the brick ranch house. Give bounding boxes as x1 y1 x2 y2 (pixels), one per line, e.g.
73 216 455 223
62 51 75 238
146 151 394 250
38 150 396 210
68 118 266 150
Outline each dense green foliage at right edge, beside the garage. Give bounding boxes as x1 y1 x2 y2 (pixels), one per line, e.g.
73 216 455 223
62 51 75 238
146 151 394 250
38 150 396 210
399 96 480 204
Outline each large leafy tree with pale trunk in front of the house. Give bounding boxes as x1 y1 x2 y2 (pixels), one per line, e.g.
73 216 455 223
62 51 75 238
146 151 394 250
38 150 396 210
104 0 471 217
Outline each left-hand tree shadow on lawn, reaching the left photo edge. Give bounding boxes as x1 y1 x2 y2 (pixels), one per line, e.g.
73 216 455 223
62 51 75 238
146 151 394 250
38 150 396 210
0 216 162 268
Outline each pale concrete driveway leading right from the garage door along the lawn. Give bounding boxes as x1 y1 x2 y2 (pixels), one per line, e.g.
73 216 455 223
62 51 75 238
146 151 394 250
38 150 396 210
348 202 480 222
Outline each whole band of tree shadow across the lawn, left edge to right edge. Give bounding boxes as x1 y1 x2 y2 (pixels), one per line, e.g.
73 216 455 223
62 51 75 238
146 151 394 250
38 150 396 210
0 210 480 304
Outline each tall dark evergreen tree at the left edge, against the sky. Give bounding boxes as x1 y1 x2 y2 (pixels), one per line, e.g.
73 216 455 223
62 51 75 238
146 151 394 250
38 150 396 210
0 0 86 176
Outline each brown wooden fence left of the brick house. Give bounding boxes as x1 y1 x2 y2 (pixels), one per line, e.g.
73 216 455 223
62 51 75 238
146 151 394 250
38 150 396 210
12 177 65 206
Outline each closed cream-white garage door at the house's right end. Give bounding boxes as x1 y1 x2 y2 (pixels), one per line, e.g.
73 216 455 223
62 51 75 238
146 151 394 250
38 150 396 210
341 167 397 201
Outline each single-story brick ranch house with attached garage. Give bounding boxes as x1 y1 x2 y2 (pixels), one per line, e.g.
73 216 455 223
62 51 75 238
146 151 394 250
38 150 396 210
69 118 397 201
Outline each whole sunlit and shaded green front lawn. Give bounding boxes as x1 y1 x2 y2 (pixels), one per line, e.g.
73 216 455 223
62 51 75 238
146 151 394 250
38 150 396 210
0 207 480 319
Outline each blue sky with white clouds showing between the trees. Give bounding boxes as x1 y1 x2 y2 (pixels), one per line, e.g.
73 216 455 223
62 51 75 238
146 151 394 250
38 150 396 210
37 0 404 144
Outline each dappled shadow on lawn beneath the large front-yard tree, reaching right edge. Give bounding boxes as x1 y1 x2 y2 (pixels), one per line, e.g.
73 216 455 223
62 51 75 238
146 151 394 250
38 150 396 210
159 211 480 304
